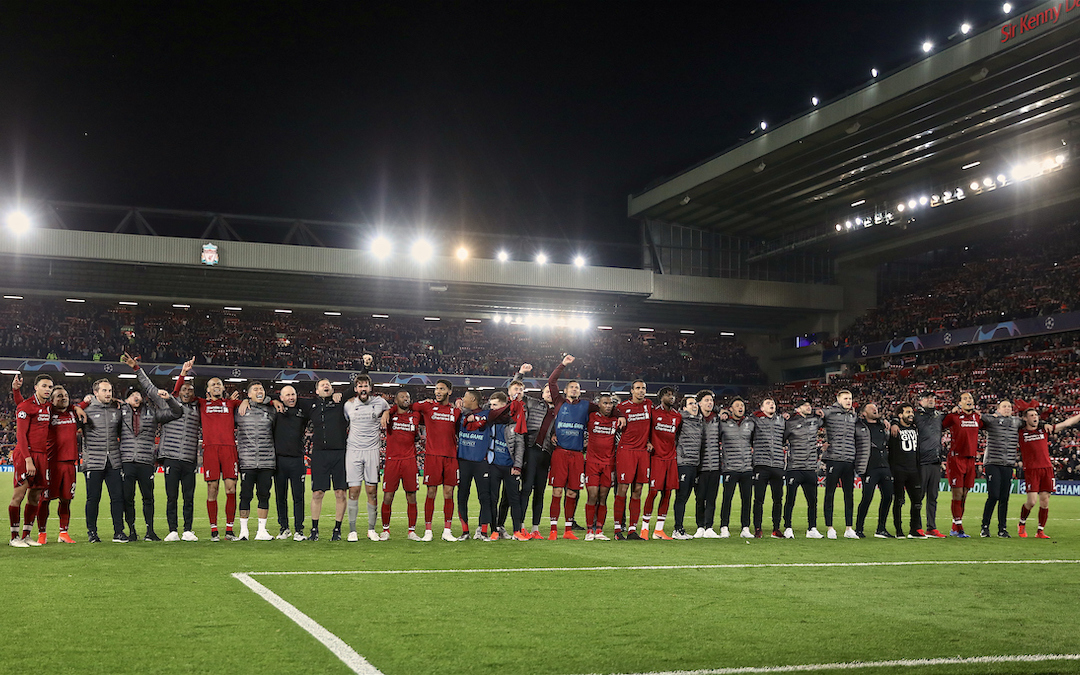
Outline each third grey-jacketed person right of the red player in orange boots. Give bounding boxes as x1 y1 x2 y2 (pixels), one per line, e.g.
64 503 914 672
720 396 756 539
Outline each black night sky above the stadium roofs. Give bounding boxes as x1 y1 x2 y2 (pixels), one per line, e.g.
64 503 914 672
0 0 1031 248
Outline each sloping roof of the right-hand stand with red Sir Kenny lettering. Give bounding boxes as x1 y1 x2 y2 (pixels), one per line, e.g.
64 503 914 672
629 2 1080 249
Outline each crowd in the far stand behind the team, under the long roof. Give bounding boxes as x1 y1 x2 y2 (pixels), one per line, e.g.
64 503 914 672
0 299 766 384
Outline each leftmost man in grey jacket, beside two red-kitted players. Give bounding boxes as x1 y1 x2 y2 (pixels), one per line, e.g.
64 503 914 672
82 379 127 543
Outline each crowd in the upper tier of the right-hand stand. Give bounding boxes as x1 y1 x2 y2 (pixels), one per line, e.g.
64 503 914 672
838 221 1080 346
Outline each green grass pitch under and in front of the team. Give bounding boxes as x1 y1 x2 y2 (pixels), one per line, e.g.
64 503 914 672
0 474 1080 675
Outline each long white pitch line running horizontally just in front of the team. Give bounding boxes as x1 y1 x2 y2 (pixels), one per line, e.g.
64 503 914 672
247 559 1080 577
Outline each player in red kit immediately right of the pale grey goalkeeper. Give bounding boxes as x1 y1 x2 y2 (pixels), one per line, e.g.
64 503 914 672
379 389 422 541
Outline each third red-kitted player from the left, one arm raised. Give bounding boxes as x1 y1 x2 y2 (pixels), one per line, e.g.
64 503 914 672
173 357 240 541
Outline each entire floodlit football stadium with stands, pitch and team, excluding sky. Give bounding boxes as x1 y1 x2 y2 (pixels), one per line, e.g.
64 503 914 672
0 0 1080 675
